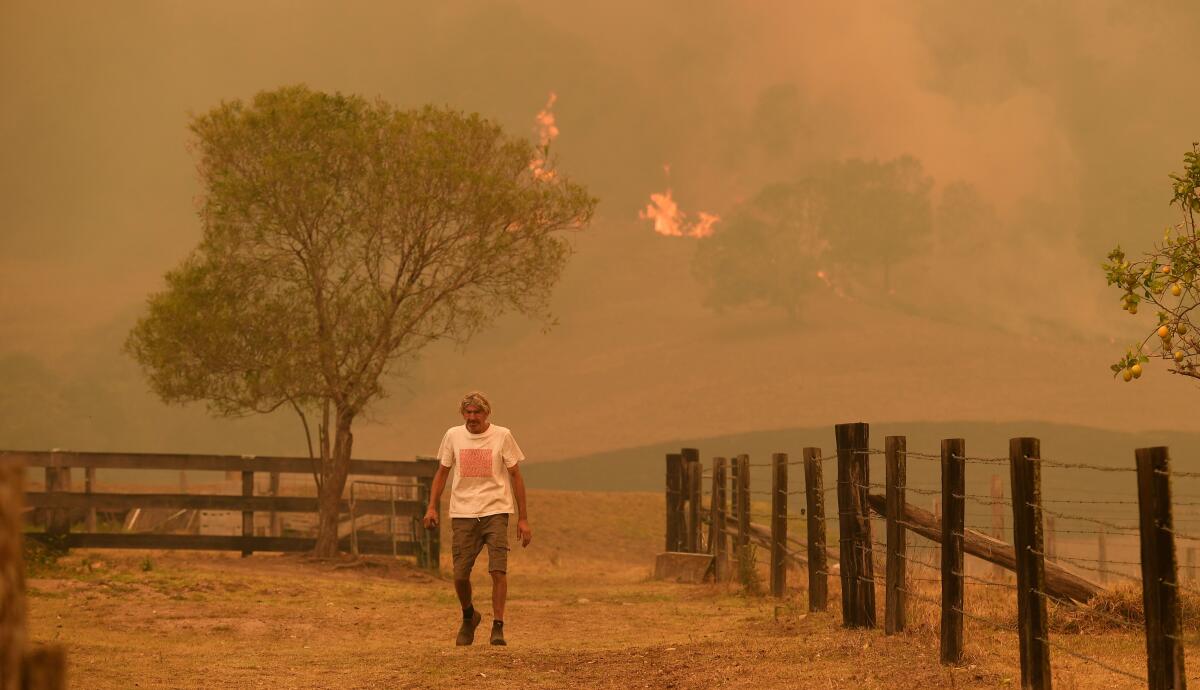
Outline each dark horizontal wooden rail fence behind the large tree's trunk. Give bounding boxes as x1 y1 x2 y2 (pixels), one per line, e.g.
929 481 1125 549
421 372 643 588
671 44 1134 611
0 451 440 570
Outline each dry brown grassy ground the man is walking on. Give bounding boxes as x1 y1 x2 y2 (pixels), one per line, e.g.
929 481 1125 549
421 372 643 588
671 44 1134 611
21 492 1194 690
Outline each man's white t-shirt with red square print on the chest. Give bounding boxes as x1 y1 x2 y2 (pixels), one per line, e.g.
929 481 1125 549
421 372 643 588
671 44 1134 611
438 424 524 517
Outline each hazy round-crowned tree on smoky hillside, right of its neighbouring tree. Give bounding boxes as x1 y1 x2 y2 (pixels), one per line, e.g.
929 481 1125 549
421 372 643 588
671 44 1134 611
823 156 934 290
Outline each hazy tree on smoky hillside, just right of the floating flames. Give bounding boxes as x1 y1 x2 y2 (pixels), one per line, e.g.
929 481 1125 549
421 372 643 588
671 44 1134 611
692 181 828 319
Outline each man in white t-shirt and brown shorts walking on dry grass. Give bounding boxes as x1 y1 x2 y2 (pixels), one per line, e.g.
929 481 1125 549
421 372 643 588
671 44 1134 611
425 391 533 644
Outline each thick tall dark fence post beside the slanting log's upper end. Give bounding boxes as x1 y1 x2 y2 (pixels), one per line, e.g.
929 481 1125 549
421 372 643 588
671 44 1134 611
834 422 875 628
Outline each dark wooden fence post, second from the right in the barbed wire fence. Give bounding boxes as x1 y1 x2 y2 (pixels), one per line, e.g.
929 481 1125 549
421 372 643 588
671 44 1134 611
1008 438 1050 690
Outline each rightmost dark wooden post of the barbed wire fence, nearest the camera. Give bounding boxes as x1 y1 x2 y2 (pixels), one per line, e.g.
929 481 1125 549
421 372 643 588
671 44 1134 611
1135 446 1187 690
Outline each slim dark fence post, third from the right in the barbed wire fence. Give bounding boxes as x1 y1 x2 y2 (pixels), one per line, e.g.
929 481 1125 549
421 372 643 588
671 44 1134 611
942 438 966 664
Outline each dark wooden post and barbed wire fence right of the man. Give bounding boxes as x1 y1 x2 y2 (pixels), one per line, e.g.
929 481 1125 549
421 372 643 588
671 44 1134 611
666 422 1200 690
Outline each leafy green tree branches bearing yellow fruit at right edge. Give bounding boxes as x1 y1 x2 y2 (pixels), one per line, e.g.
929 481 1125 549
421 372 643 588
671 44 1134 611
1103 143 1200 382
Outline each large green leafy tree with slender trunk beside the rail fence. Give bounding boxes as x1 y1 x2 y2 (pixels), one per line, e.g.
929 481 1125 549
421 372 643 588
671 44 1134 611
126 86 596 557
